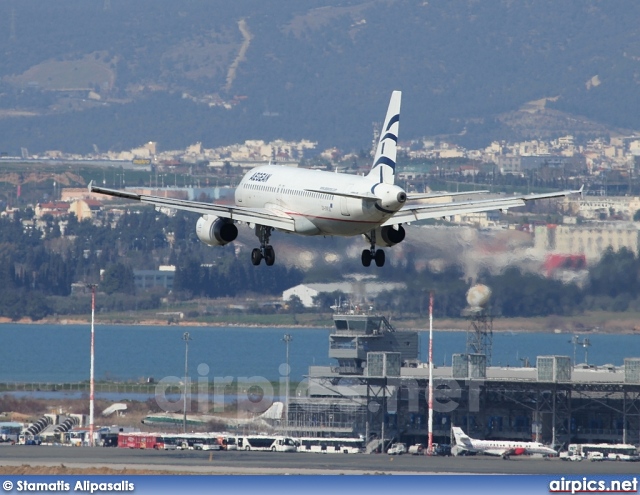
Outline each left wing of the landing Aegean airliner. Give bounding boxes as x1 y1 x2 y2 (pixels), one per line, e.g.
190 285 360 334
89 182 295 232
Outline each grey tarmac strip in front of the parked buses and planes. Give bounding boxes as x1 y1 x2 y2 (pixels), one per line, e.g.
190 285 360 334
0 445 639 475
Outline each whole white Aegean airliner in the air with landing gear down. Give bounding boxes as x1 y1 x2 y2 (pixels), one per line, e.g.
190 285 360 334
89 91 580 266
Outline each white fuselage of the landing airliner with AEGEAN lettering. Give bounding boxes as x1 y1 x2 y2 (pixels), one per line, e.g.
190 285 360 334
235 165 404 236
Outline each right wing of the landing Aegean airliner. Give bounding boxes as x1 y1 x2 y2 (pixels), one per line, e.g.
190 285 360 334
382 188 582 227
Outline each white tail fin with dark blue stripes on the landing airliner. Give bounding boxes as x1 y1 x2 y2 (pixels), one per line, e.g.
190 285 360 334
367 91 402 184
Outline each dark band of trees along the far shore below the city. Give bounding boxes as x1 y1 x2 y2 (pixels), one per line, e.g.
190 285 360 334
0 200 640 320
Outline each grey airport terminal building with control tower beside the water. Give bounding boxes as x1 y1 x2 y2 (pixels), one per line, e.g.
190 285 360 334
287 311 640 451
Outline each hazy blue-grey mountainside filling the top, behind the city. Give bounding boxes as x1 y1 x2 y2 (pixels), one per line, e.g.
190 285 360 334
0 0 640 155
